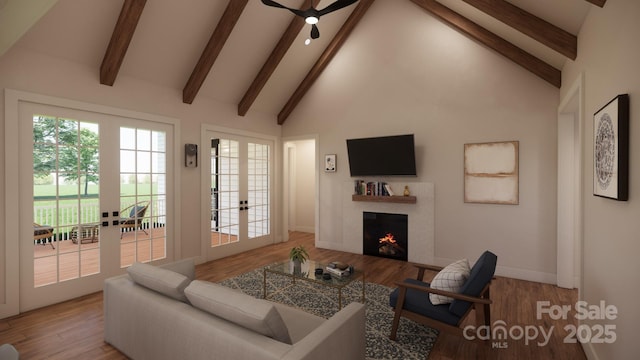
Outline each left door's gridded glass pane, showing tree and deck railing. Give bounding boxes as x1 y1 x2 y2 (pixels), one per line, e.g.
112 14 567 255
32 114 100 287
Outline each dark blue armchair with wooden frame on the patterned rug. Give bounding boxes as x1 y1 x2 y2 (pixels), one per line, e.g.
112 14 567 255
389 251 497 358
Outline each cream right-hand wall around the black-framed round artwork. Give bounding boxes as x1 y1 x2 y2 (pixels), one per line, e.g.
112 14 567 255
561 0 640 359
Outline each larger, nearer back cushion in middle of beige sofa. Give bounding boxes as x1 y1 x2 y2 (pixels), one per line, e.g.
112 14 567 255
185 280 291 344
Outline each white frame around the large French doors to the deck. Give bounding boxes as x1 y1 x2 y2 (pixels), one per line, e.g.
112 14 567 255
0 89 182 319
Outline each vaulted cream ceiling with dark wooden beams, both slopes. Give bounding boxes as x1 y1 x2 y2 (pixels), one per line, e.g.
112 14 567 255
0 0 606 124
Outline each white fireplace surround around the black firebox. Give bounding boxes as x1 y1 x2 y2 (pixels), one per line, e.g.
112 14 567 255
342 181 435 264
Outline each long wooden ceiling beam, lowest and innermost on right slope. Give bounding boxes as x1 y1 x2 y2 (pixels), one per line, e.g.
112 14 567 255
411 0 562 88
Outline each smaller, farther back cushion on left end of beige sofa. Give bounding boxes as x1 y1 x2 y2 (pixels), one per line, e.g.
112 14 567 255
127 262 191 302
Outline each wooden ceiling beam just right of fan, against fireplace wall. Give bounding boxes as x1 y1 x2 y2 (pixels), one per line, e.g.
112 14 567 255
278 0 374 125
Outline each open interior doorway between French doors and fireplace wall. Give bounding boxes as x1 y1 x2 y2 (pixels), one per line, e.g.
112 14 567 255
283 138 318 240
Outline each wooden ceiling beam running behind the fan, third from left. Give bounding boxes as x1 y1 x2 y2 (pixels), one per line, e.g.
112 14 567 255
238 0 320 116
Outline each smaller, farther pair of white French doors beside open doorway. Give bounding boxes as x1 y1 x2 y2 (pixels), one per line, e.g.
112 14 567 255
203 131 273 260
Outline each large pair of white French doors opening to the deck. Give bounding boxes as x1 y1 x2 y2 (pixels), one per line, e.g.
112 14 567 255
18 103 174 311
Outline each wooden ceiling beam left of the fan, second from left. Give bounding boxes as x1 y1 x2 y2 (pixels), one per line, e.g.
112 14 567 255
182 0 249 104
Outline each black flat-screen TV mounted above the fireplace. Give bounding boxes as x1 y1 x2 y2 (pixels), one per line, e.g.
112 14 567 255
347 134 416 176
